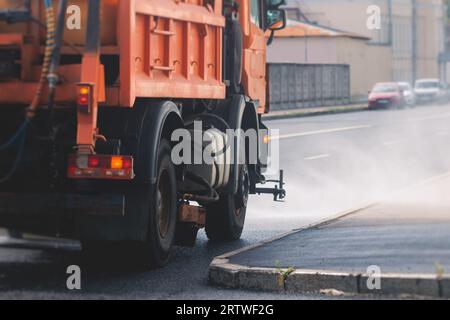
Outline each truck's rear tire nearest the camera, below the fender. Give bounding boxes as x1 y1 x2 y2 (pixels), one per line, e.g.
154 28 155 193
82 140 178 269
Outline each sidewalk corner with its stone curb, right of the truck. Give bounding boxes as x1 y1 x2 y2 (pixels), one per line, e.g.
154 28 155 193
210 175 450 298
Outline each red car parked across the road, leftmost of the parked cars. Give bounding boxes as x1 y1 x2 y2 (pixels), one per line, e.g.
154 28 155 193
369 82 406 109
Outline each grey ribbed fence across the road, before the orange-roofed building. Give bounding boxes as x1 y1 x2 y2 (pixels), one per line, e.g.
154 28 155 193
269 63 351 111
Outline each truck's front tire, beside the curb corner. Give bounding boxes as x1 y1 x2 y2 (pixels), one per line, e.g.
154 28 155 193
206 165 250 242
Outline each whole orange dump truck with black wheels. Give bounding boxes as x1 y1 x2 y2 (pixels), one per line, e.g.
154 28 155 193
0 0 286 266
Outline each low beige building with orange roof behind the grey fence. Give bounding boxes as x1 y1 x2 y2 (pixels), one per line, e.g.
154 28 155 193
267 20 392 102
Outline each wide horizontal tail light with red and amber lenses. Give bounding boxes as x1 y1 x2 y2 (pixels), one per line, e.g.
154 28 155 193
68 154 134 180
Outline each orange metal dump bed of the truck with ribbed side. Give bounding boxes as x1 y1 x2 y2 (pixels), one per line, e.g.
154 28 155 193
0 0 226 107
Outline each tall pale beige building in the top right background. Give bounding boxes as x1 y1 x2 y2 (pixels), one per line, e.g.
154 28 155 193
287 0 446 82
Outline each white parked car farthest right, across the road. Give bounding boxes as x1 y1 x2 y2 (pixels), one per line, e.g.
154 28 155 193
414 79 450 103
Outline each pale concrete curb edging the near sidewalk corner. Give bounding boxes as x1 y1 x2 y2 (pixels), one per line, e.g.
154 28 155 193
209 203 450 299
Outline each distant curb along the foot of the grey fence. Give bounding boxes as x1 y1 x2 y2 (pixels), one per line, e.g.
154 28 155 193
263 104 369 120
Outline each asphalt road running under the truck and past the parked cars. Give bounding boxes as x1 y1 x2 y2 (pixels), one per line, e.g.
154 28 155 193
0 106 450 299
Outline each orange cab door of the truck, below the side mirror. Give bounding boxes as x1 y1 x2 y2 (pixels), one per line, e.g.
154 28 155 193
240 0 267 112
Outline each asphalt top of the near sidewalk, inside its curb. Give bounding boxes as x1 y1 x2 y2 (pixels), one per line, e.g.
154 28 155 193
229 171 450 275
